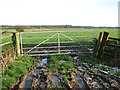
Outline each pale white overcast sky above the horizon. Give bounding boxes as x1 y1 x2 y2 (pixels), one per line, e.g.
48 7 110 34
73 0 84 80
0 0 119 26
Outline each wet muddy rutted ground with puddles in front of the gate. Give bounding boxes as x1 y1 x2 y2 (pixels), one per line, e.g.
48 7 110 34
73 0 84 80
13 56 120 90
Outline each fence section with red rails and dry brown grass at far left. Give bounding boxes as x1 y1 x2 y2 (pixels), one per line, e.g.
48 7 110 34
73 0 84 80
0 35 16 74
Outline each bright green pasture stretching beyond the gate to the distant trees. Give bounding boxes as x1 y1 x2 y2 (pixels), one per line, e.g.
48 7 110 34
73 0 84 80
0 28 118 50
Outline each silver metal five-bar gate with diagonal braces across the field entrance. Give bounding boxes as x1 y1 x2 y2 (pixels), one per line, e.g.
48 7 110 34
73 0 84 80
20 31 95 56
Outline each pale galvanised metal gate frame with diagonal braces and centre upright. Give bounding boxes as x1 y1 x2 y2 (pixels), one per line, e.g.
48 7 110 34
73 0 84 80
20 31 95 56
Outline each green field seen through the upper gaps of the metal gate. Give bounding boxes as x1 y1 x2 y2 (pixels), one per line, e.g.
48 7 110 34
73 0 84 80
21 32 94 43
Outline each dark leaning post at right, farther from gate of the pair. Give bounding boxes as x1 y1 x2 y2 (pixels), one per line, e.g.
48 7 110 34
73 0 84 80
97 32 109 58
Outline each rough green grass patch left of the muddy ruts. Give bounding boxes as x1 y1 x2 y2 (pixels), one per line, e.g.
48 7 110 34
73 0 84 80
2 56 35 89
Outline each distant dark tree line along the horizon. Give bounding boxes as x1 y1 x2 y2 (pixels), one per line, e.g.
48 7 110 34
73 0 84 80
2 25 120 29
